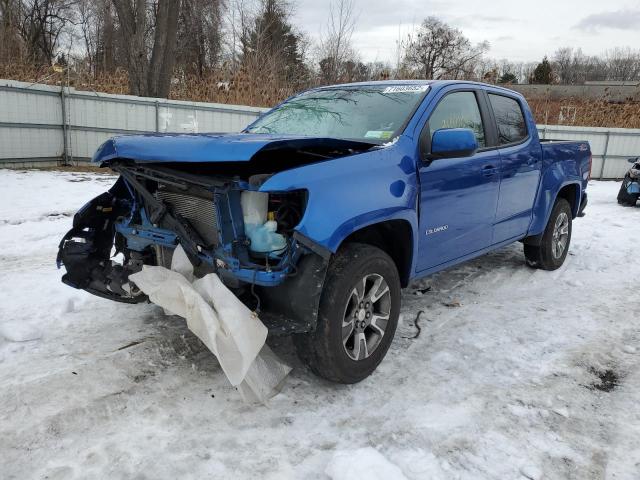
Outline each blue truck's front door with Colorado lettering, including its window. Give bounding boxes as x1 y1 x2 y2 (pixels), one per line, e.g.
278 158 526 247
417 89 500 272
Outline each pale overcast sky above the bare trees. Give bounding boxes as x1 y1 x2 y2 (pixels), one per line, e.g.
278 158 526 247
293 0 640 63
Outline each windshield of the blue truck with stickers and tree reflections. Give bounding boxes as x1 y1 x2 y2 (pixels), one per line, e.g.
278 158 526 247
246 85 429 143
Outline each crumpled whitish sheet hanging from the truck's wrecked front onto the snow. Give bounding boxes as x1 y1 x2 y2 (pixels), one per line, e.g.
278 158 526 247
129 246 291 403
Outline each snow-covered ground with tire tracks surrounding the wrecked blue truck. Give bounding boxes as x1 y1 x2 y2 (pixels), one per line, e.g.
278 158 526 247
0 170 640 480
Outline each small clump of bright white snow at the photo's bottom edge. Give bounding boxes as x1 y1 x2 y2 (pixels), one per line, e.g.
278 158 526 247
325 447 407 480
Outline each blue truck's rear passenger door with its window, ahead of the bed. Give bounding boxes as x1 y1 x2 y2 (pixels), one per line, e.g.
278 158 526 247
487 92 542 243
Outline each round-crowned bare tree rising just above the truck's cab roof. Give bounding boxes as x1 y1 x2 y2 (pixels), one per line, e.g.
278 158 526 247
404 17 489 79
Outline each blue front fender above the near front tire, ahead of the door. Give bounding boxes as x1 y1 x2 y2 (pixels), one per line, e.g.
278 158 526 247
260 135 418 253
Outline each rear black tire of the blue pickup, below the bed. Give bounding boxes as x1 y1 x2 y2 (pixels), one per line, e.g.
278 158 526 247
524 198 572 270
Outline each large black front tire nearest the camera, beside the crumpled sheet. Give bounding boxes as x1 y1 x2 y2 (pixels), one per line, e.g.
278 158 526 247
294 243 401 384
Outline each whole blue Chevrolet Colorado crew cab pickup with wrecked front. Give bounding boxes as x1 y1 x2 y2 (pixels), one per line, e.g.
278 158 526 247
58 81 591 383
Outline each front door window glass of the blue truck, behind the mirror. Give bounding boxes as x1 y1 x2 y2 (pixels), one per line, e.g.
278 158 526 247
429 92 486 148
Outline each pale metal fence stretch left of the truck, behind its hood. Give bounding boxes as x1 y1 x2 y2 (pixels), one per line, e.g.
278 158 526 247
0 80 266 166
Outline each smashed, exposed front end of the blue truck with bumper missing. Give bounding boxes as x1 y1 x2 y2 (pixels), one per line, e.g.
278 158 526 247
57 160 330 333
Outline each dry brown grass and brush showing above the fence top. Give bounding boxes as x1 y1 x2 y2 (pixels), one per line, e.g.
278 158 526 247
0 65 640 128
